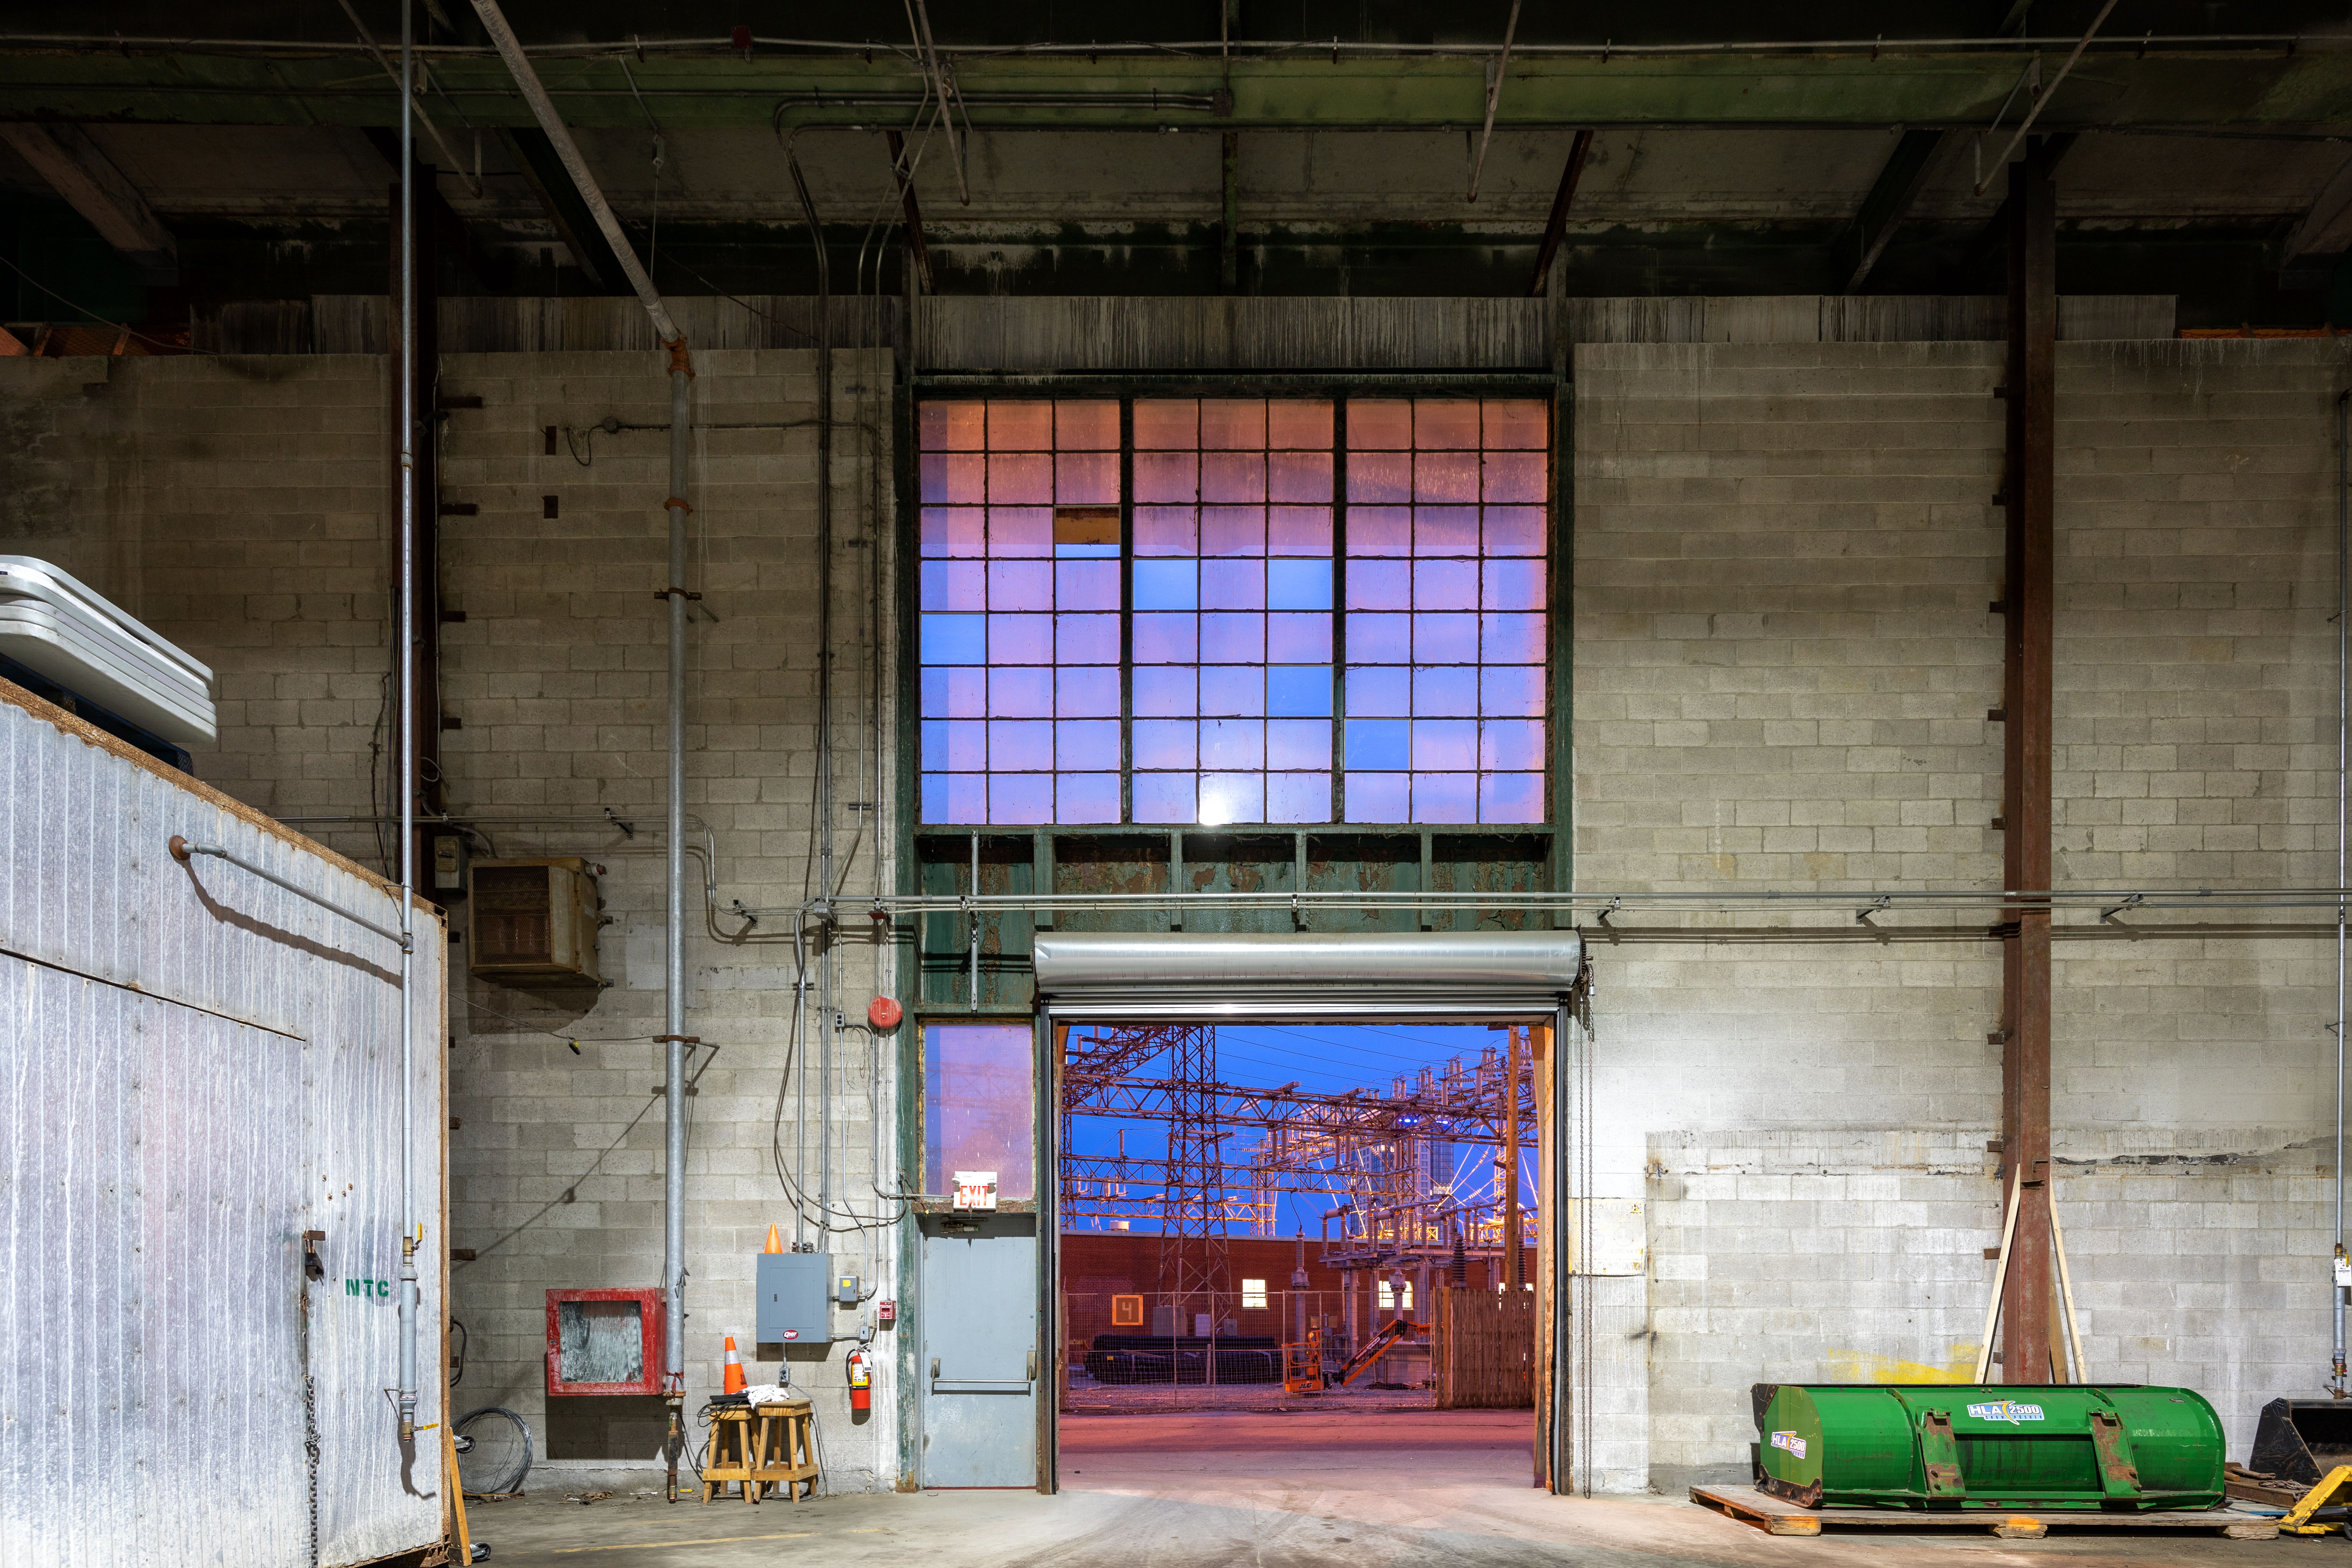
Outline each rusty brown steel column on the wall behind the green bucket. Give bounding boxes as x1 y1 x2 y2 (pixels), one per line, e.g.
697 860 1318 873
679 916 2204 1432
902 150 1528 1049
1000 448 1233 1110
1999 144 2058 1382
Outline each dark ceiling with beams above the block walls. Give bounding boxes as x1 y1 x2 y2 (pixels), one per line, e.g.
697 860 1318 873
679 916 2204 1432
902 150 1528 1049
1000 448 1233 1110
0 0 2352 327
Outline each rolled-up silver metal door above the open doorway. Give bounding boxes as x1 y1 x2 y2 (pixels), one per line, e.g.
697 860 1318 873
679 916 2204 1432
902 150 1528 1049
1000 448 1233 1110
1035 931 1585 1023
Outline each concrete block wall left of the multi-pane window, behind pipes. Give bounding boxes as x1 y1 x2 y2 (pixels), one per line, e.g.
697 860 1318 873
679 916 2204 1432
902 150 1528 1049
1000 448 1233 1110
0 350 898 1490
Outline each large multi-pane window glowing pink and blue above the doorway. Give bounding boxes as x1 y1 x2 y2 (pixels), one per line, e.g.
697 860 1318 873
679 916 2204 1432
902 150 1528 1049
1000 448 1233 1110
920 397 1550 825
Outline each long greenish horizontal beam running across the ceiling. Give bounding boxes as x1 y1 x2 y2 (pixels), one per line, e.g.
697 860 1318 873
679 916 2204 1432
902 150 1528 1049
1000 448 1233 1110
0 49 2352 132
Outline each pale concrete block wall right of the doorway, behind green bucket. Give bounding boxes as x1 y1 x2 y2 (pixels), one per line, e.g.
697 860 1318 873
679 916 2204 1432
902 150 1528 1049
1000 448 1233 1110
1574 341 2345 1490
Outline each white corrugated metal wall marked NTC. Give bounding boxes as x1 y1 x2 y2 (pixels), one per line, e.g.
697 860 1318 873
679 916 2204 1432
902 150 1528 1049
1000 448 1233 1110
0 684 447 1568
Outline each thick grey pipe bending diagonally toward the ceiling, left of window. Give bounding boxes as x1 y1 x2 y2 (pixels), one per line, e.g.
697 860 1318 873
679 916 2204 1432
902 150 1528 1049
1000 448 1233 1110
473 0 696 1502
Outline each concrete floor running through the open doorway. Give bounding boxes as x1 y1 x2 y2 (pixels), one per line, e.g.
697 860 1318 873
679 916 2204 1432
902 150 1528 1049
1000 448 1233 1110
475 1410 2295 1568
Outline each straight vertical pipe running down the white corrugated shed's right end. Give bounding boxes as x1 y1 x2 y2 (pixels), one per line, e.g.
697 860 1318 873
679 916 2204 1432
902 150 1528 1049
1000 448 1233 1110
395 0 424 1446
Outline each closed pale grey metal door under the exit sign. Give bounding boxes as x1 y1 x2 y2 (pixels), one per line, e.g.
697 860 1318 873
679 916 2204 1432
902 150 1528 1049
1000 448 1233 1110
915 1216 1040 1486
